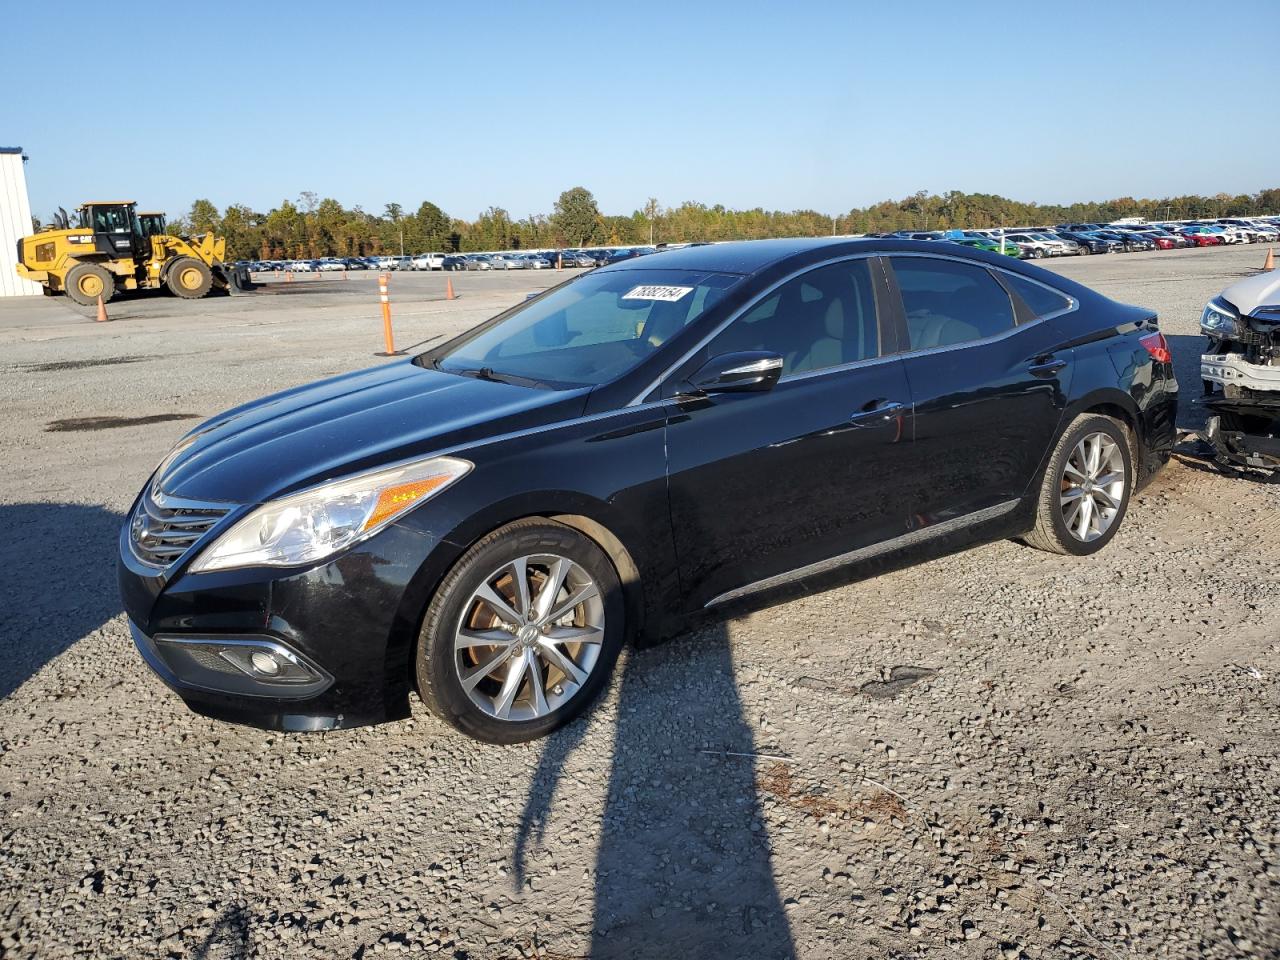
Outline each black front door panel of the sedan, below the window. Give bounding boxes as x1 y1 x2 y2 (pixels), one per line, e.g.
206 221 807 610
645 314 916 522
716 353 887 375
667 358 911 607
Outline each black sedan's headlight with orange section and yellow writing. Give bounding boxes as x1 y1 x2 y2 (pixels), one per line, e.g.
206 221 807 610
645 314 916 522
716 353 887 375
191 457 471 573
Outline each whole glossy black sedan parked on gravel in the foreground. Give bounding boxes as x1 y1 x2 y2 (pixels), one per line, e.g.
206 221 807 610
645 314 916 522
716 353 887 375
119 239 1176 742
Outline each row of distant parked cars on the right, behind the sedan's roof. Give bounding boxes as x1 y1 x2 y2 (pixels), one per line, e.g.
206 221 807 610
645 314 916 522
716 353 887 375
870 216 1280 260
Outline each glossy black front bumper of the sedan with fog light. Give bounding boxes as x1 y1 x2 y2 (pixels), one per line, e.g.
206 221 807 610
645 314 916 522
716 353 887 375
118 514 452 730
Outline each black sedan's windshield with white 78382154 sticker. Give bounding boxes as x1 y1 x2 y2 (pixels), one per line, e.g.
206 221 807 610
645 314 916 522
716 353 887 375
415 270 742 389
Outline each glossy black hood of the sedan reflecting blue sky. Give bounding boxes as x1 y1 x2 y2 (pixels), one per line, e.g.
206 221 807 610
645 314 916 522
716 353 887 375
156 361 588 503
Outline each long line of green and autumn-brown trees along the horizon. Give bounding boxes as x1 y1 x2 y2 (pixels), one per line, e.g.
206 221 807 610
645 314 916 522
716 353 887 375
82 187 1280 260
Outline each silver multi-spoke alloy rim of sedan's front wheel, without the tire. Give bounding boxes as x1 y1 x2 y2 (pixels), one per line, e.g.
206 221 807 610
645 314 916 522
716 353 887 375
453 554 604 722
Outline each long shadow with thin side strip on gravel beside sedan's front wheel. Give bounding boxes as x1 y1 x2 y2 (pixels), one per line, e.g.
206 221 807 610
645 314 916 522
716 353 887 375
513 623 795 960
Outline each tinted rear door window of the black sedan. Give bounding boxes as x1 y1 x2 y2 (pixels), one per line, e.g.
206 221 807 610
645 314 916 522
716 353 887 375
892 257 1014 349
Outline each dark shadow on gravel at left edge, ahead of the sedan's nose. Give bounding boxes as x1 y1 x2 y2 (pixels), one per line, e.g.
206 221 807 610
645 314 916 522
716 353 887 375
0 503 124 699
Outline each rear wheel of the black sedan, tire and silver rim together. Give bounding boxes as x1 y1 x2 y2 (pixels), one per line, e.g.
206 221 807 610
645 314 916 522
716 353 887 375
1023 413 1134 557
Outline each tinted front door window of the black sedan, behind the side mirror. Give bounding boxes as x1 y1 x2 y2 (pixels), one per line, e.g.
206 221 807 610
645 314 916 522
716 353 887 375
709 260 879 375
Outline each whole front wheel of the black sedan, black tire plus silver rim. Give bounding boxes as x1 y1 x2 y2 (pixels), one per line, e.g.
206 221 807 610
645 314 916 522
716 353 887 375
415 518 626 744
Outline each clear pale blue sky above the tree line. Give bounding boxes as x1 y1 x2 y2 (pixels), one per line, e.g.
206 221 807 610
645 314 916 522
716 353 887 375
0 0 1280 218
